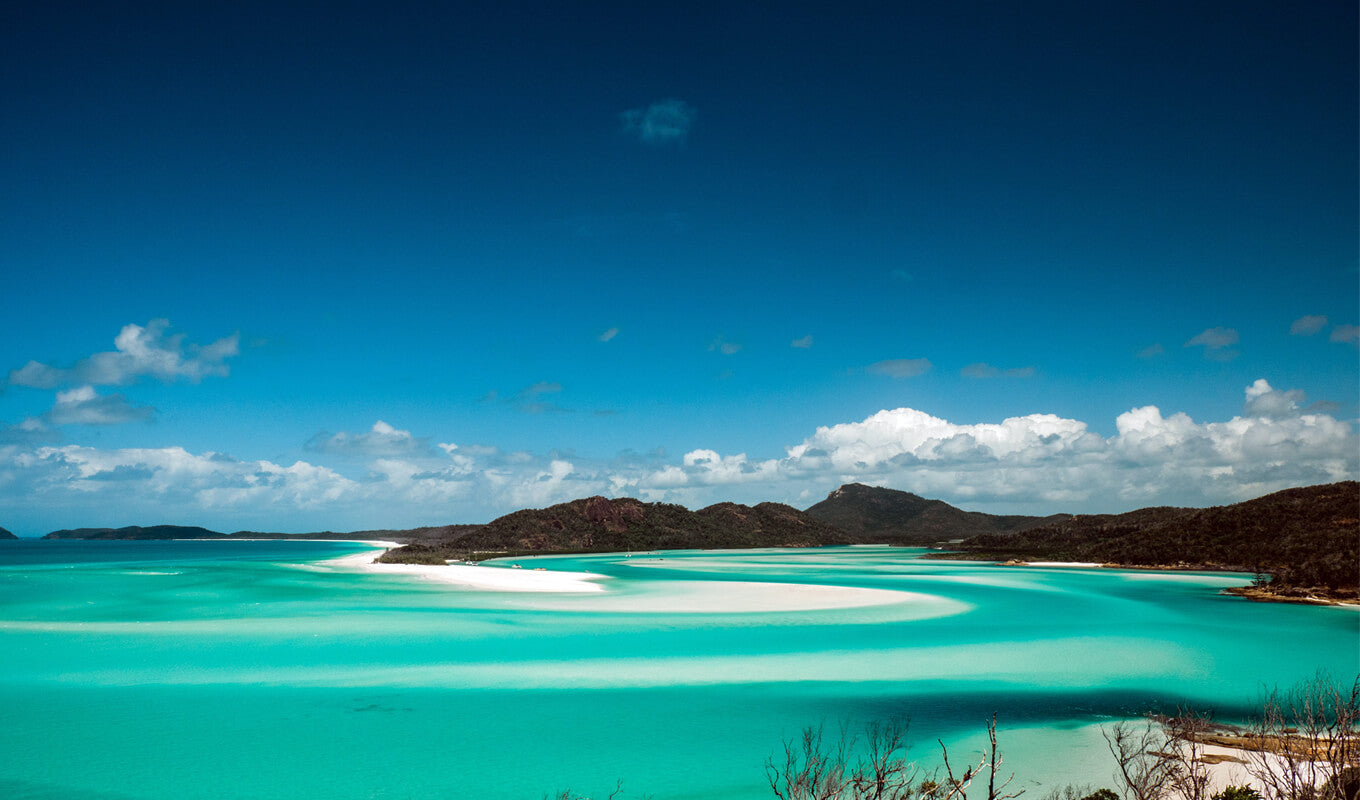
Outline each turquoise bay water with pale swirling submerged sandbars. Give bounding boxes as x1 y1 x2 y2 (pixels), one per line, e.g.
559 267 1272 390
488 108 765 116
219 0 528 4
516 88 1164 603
0 541 1360 800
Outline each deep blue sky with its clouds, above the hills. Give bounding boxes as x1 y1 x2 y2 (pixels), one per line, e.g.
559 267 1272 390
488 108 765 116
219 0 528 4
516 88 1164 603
0 1 1360 536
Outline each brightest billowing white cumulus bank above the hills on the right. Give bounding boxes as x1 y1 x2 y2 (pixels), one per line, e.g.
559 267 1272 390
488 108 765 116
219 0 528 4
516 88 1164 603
641 380 1360 513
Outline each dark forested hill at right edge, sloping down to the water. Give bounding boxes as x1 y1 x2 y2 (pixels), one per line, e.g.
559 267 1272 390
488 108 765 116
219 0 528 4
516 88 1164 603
956 480 1360 592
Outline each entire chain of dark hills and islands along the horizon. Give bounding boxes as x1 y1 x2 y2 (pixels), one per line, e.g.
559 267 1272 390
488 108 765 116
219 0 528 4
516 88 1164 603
13 480 1360 600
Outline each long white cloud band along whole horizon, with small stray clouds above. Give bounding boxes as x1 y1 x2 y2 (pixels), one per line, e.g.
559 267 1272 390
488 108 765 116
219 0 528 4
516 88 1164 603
0 322 1360 533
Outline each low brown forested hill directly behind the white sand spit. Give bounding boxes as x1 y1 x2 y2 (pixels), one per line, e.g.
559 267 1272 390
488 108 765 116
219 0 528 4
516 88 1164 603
382 497 851 563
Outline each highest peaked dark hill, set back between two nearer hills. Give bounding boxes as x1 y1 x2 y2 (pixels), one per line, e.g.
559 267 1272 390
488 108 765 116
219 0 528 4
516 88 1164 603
808 483 1069 544
